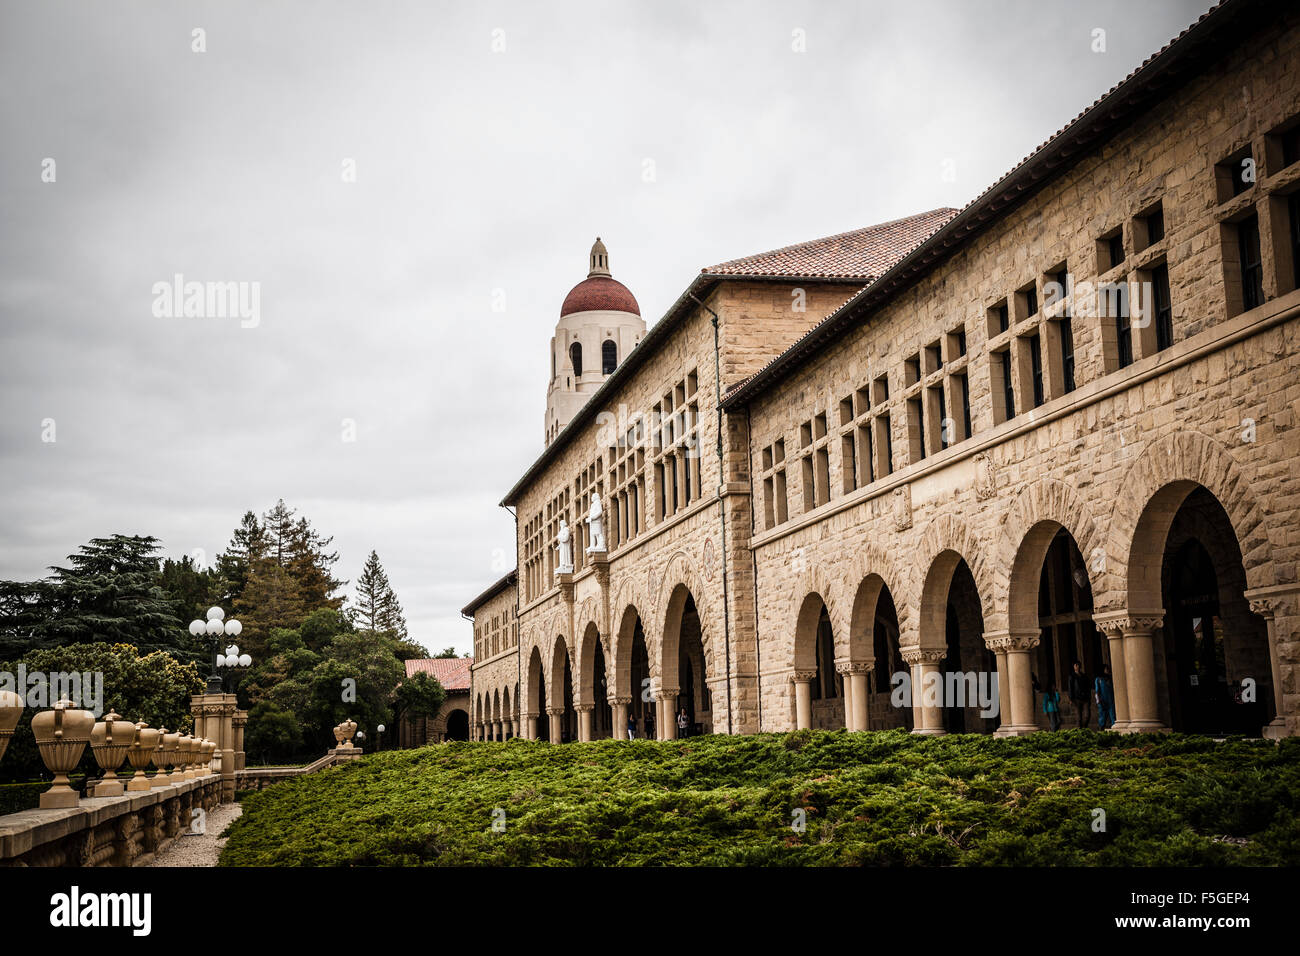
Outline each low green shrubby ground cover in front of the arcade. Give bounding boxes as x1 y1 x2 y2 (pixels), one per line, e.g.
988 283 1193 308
221 731 1300 866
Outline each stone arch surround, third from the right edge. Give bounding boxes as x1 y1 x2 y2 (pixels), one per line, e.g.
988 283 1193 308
915 515 993 650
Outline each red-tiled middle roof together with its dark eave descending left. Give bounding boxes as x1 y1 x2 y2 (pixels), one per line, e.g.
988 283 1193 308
501 208 956 509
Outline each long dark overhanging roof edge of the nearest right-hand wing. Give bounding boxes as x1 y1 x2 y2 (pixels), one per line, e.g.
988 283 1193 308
723 0 1258 408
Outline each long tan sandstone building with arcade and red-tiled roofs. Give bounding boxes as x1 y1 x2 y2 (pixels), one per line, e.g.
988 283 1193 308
465 0 1300 741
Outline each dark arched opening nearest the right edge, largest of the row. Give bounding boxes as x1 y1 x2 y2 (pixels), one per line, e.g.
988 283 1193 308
1154 485 1277 736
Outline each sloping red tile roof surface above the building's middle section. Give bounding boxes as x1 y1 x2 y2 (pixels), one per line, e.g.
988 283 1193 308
701 208 957 280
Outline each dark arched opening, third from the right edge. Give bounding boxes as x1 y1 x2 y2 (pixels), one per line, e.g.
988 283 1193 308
911 550 1000 734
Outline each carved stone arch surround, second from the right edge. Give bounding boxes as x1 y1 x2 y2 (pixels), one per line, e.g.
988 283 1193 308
993 477 1105 631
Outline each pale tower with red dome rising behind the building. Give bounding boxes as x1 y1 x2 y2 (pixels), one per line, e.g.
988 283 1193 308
546 237 646 445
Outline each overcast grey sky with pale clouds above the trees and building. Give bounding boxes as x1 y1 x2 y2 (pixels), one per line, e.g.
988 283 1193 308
0 0 1209 650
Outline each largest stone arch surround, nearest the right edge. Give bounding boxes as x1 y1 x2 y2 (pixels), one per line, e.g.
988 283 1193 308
1097 432 1277 611
